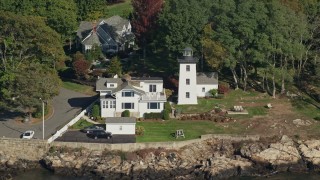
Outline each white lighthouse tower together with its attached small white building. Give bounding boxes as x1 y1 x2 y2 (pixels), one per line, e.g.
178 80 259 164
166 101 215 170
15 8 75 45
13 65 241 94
178 48 218 104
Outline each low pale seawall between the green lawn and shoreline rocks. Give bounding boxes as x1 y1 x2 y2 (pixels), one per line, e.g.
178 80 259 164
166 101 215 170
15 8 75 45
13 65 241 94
52 134 260 152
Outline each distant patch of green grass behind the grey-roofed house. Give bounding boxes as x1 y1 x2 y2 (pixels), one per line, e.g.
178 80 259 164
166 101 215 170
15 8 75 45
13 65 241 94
107 0 133 18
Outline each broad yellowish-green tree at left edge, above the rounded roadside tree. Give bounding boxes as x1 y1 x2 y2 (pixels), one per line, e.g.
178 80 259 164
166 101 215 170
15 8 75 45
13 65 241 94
0 11 65 71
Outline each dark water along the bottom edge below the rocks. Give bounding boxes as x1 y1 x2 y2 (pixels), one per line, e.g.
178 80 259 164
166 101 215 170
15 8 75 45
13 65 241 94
13 169 320 180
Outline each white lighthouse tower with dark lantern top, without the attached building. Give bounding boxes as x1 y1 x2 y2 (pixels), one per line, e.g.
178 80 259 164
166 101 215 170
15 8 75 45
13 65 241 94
178 47 198 104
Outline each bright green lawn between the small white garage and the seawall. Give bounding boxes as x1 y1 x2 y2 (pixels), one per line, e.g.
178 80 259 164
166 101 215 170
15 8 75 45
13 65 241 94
137 120 224 142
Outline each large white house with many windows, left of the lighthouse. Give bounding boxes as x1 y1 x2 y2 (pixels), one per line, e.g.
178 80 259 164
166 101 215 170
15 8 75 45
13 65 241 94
96 77 166 117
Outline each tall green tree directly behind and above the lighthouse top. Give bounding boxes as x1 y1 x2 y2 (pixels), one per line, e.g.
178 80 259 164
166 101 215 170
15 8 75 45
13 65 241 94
157 0 212 55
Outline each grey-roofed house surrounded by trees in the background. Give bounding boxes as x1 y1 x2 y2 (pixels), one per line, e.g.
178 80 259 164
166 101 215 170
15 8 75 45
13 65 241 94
77 16 134 53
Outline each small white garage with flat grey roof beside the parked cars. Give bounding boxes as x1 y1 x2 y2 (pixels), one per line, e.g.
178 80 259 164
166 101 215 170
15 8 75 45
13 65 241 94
106 117 136 135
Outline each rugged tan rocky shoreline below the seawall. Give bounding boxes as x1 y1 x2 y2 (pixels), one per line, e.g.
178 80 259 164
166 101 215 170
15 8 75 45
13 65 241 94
0 136 320 179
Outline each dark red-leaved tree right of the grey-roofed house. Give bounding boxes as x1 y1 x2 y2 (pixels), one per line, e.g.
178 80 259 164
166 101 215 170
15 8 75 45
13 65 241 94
132 0 163 58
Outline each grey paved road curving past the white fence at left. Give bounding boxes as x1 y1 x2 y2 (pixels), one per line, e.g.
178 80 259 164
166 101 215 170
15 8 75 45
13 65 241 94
0 88 97 139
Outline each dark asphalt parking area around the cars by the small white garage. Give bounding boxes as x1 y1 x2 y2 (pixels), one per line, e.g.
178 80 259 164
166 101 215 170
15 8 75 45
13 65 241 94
55 130 136 144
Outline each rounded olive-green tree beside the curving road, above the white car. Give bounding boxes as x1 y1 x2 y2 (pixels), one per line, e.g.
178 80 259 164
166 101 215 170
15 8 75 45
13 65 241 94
7 63 60 118
